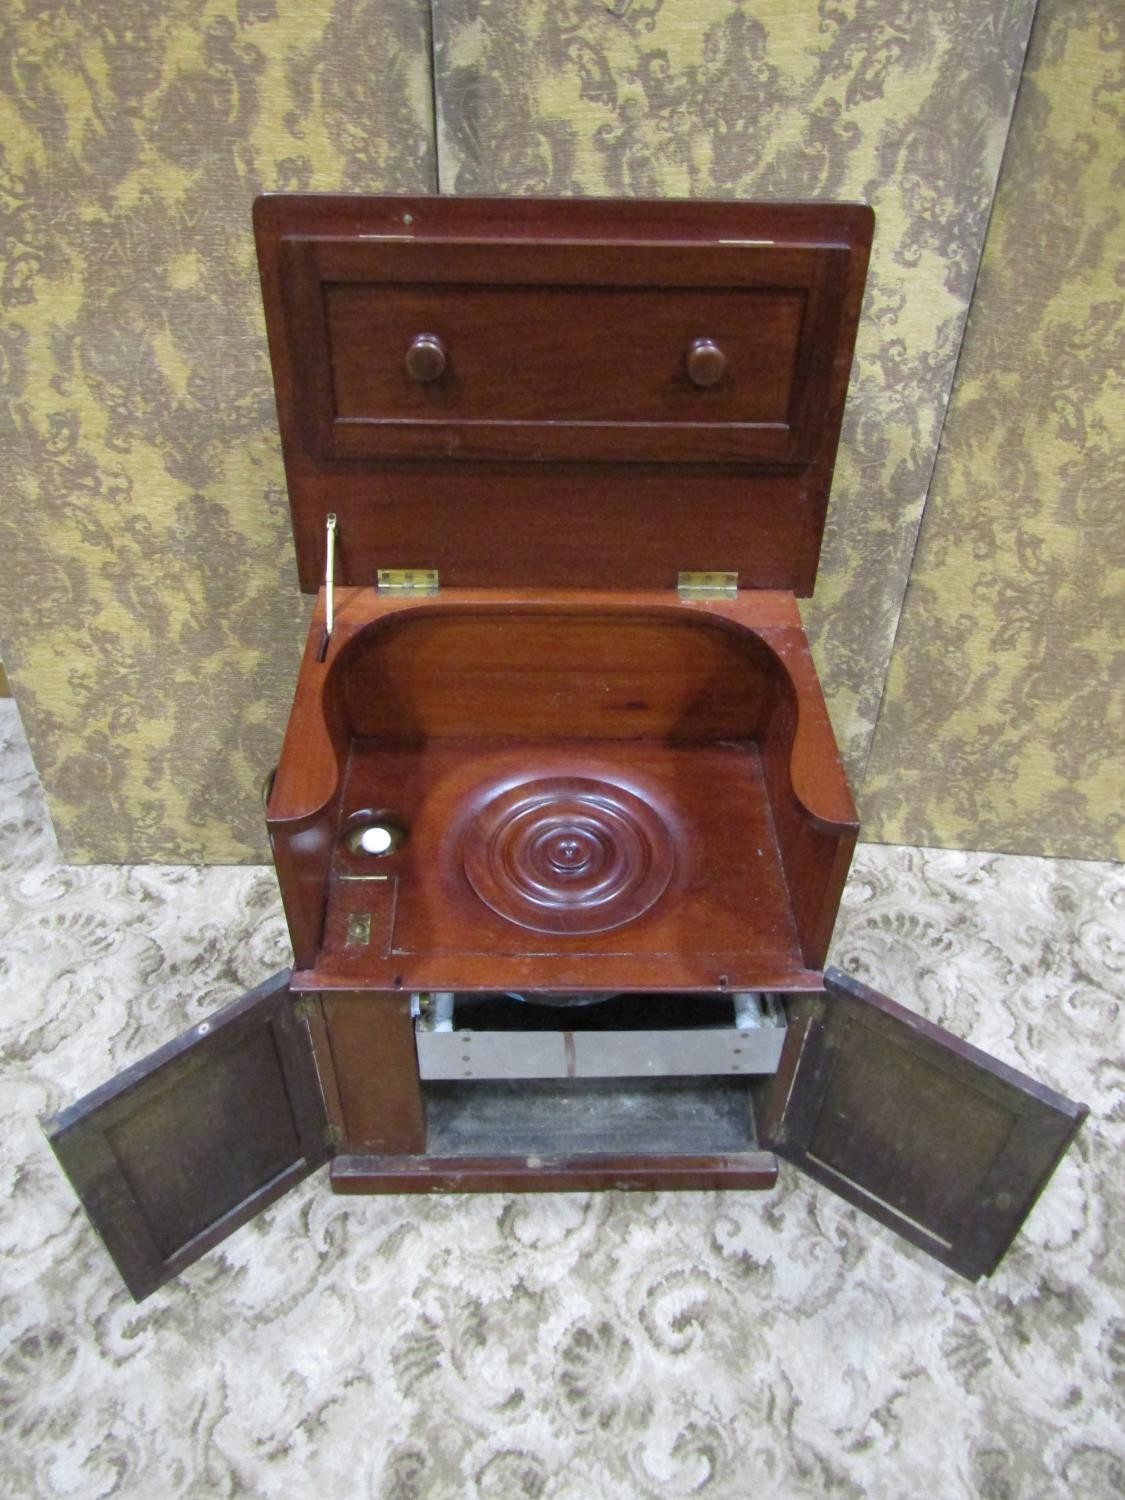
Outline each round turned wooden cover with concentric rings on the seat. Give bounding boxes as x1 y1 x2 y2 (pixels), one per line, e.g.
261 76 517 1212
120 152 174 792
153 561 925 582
464 777 675 933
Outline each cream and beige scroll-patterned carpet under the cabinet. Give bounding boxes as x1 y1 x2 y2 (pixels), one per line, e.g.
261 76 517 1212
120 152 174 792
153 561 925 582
0 702 1125 1500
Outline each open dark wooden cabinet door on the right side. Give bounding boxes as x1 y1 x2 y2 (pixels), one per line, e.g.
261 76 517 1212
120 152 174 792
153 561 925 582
762 969 1088 1281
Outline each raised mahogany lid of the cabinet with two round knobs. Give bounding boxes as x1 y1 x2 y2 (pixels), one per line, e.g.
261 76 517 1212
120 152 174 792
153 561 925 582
255 195 873 594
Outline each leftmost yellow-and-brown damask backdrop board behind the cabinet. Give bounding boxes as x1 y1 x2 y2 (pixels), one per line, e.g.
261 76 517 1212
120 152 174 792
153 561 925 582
0 0 435 861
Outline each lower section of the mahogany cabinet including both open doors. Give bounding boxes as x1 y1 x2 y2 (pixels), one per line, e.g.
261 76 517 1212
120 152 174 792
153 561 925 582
44 969 1086 1301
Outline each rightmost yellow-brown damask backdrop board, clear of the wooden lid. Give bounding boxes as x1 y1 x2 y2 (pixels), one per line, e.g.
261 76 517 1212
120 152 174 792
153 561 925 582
863 0 1125 858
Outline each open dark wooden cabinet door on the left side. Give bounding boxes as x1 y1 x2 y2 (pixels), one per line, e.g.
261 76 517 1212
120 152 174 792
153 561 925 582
44 971 329 1302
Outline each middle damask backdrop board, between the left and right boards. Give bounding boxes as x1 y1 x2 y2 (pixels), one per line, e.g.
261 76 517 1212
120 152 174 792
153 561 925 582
435 0 1034 773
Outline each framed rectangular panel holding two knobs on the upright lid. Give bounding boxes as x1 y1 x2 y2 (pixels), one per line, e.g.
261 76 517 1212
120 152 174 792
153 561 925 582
281 236 848 464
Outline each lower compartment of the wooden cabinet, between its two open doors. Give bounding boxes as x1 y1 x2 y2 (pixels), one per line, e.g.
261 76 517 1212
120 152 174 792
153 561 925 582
320 995 786 1193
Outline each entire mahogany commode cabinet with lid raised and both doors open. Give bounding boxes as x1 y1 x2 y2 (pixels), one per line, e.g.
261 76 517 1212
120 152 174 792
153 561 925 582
47 195 1085 1298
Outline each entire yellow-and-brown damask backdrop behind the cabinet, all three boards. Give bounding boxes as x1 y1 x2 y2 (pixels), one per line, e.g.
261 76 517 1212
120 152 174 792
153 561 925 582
0 0 1122 861
